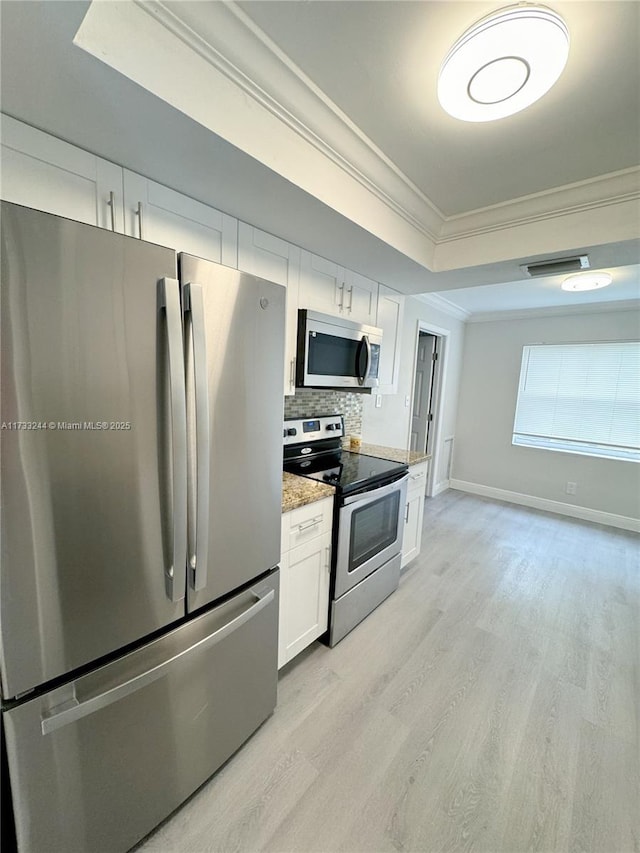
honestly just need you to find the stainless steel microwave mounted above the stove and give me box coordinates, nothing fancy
[296,309,382,391]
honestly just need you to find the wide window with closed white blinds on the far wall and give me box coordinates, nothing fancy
[513,341,640,462]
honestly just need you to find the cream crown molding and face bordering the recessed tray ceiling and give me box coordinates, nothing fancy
[74,0,640,271]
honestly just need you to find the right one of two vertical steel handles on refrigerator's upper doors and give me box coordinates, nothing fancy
[184,282,211,590]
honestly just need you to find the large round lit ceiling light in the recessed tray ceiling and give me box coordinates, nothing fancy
[438,4,569,121]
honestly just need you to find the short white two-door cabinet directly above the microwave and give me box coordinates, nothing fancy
[299,251,378,326]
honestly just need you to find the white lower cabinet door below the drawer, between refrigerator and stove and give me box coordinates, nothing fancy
[278,536,331,666]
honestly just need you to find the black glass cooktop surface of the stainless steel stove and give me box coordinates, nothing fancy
[284,450,407,494]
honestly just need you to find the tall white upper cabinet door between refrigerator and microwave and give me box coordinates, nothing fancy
[238,222,300,395]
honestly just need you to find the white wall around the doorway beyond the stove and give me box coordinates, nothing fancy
[362,297,465,487]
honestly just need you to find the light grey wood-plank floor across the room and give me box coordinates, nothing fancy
[138,491,640,853]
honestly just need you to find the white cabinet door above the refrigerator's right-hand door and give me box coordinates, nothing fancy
[124,169,238,269]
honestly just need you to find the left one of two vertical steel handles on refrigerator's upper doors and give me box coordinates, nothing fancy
[158,278,187,602]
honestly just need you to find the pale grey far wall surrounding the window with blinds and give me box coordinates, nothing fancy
[452,311,640,523]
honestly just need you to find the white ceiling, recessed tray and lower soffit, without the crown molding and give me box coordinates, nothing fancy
[0,0,640,312]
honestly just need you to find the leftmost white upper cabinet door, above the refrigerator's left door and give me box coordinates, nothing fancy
[2,116,123,233]
